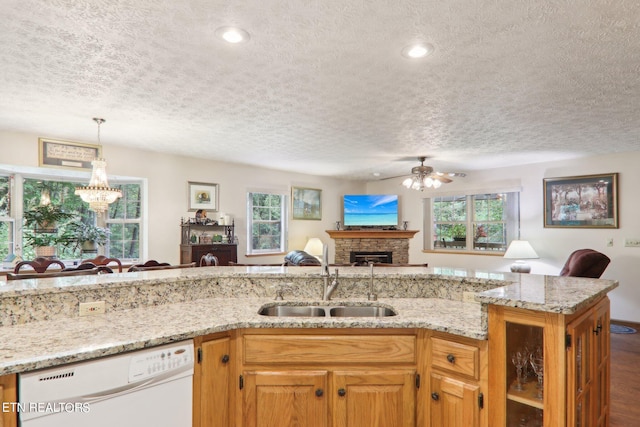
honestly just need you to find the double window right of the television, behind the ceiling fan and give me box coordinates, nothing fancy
[425,192,520,252]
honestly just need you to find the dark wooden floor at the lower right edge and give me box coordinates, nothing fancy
[610,321,640,427]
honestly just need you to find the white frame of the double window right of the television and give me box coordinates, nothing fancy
[423,189,520,256]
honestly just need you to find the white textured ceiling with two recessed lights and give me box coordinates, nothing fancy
[0,0,640,179]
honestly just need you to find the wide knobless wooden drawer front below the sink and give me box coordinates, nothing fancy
[244,335,416,364]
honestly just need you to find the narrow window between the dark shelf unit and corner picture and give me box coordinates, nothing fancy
[247,192,287,255]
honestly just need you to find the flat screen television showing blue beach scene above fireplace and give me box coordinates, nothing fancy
[343,194,398,227]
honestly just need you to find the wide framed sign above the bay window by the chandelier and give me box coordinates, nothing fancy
[38,138,102,170]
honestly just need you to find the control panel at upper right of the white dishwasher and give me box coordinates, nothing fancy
[129,341,194,383]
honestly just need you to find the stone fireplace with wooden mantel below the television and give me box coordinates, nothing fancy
[327,230,418,264]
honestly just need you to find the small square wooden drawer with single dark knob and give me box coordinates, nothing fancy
[431,338,479,379]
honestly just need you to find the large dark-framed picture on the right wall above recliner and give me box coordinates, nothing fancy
[543,173,618,228]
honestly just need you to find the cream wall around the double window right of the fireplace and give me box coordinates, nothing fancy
[367,152,640,322]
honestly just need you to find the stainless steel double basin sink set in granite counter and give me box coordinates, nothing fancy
[258,304,398,317]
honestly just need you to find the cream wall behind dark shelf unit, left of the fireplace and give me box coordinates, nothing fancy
[0,131,364,264]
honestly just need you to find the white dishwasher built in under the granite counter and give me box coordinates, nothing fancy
[18,340,194,427]
